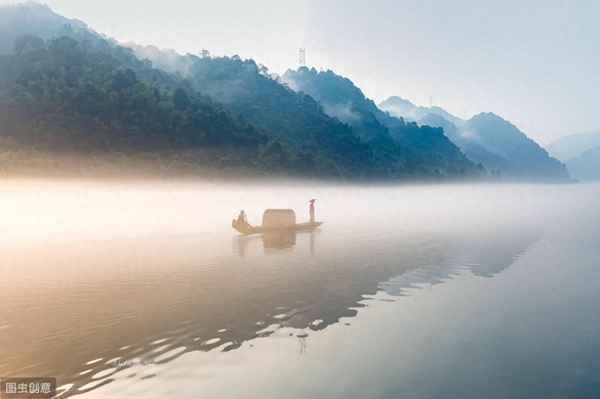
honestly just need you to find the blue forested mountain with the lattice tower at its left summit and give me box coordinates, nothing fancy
[282,67,478,174]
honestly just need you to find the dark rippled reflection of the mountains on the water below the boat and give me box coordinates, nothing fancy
[0,225,537,392]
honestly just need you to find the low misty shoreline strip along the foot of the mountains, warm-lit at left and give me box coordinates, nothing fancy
[0,148,576,184]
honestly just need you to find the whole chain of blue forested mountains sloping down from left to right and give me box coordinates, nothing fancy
[0,3,562,179]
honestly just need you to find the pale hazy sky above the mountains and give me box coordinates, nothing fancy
[5,0,600,143]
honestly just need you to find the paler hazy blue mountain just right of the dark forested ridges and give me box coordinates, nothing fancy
[380,97,569,181]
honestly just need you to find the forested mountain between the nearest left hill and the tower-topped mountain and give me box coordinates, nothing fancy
[127,46,392,178]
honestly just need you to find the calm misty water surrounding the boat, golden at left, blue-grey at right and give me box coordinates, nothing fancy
[0,180,600,398]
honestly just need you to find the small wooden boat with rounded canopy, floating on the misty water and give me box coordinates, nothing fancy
[231,209,323,235]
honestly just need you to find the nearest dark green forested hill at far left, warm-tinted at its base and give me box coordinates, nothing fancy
[0,36,265,150]
